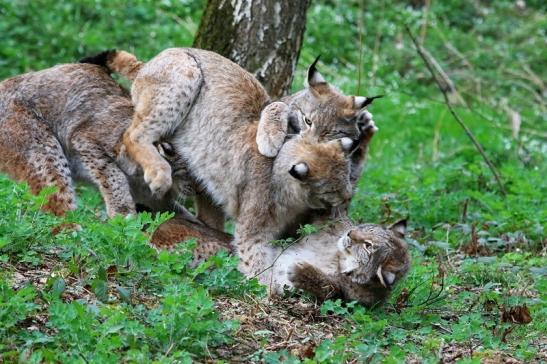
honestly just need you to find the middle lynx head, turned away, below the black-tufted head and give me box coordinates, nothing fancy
[273,130,353,209]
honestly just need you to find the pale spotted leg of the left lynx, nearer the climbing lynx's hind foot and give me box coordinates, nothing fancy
[72,135,136,217]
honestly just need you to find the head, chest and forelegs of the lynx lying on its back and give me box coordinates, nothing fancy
[284,220,410,306]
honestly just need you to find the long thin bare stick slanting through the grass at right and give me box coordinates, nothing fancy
[405,25,506,195]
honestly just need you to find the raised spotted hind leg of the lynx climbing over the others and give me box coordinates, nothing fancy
[123,50,203,196]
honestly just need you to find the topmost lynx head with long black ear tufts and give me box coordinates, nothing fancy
[282,57,381,141]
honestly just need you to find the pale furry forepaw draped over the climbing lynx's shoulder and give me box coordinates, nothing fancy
[256,101,289,158]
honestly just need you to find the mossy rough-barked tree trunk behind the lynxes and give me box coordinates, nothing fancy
[194,0,311,98]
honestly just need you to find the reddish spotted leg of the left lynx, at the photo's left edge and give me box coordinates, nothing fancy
[0,110,76,216]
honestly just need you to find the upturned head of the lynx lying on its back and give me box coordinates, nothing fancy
[338,220,410,295]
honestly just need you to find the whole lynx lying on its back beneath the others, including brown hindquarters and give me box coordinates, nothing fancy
[151,217,410,306]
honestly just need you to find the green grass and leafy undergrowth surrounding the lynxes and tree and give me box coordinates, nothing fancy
[0,0,547,363]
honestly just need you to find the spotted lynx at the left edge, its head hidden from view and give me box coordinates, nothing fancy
[0,64,196,218]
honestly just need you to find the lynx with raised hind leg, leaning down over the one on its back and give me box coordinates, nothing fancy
[81,48,357,274]
